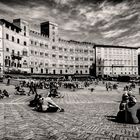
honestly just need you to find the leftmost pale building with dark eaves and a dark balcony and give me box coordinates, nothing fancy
[0,19,29,73]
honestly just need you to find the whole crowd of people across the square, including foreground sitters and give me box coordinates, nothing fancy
[0,76,140,123]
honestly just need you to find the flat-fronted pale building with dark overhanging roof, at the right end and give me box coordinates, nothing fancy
[95,45,138,77]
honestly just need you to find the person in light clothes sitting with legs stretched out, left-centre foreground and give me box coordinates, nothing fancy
[36,95,64,112]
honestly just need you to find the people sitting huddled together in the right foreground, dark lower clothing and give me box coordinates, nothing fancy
[117,88,140,124]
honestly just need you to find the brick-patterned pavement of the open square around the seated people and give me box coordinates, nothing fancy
[0,84,140,140]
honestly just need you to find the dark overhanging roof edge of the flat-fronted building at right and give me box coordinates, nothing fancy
[94,44,138,49]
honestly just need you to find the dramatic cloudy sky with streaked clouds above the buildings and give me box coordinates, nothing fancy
[0,0,140,46]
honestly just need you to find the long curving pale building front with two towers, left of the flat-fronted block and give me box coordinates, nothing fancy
[0,19,95,74]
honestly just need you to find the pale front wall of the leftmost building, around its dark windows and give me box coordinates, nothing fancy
[3,22,29,72]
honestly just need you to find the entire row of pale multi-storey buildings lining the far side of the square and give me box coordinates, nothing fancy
[0,19,138,77]
